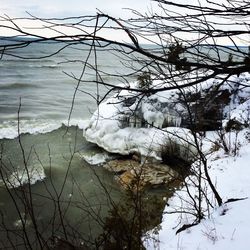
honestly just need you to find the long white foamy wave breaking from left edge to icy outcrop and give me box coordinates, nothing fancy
[0,119,87,139]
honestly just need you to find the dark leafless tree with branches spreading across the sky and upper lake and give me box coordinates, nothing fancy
[0,0,250,247]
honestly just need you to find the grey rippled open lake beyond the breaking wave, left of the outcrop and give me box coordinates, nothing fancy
[0,38,137,131]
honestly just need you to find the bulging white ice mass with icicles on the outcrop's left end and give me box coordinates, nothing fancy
[83,83,194,160]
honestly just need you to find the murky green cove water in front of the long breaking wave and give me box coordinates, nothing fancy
[0,127,122,244]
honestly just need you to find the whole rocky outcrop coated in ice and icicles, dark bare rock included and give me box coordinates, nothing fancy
[83,74,250,162]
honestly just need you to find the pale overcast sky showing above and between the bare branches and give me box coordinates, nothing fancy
[0,0,249,44]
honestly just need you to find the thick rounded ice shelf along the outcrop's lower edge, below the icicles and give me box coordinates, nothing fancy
[84,120,192,160]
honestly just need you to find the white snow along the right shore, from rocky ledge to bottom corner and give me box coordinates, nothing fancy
[143,74,250,250]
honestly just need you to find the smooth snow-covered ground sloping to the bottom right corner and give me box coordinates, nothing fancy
[147,130,250,250]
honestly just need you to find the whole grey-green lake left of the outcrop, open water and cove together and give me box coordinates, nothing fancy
[0,38,172,249]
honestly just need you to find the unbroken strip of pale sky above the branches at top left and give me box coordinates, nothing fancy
[0,0,150,18]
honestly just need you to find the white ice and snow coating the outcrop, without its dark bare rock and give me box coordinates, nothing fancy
[83,74,250,160]
